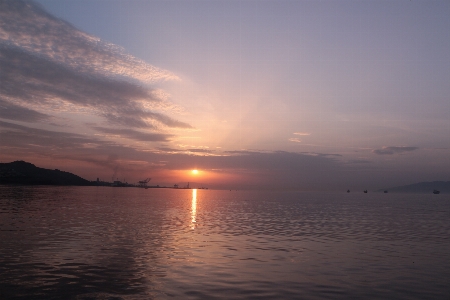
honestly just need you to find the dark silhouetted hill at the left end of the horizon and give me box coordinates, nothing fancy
[0,161,91,185]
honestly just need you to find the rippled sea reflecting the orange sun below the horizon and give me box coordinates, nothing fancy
[0,186,450,300]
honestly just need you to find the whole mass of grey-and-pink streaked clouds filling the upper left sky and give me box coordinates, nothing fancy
[0,1,192,129]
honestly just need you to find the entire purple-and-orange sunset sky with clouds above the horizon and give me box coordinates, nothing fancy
[0,0,450,190]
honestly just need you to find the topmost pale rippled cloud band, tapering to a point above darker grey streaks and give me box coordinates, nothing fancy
[0,0,178,82]
